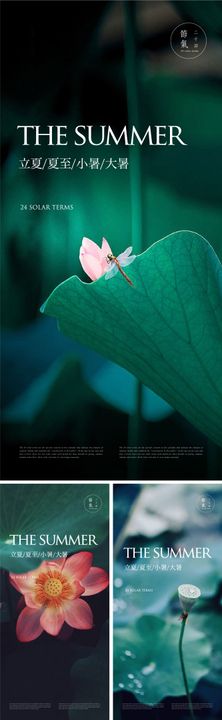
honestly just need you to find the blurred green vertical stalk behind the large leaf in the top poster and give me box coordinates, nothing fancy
[124,0,143,480]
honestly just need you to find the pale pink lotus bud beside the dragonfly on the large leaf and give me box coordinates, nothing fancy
[79,238,112,280]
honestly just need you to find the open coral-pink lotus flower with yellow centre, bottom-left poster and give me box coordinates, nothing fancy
[9,552,109,642]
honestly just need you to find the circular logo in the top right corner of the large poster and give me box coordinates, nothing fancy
[170,22,207,60]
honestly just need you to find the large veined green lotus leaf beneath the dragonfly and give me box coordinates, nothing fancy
[42,231,222,445]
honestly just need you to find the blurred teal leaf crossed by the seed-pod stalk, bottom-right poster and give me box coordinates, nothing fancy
[114,616,210,705]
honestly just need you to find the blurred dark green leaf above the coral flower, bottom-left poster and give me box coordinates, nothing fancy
[0,483,109,572]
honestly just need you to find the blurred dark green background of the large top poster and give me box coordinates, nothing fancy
[2,1,222,480]
